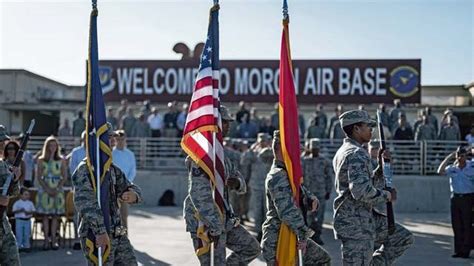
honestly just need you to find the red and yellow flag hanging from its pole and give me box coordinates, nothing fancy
[276,1,303,265]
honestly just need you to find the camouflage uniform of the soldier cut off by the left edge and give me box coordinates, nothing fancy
[0,160,20,266]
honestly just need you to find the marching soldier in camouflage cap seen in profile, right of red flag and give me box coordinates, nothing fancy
[333,110,413,265]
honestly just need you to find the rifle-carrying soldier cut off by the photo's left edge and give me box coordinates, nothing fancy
[0,134,21,266]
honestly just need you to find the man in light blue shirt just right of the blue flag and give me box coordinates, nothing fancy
[112,130,137,227]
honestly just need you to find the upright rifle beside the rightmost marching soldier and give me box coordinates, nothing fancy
[377,111,395,235]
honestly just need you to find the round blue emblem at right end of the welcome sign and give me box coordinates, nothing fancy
[390,66,420,97]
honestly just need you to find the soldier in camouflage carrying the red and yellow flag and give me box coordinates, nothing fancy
[261,130,331,265]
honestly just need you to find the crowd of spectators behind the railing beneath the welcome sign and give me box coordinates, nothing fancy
[58,99,474,147]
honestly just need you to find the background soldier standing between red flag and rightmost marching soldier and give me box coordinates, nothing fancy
[301,139,334,245]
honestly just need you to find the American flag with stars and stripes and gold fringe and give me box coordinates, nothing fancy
[181,4,225,249]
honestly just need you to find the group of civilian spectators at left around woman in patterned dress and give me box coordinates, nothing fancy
[0,122,137,251]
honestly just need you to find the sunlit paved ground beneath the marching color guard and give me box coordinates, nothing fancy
[21,207,474,266]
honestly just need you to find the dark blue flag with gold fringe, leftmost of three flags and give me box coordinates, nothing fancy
[85,6,112,264]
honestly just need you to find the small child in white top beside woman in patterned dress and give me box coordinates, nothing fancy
[13,188,35,251]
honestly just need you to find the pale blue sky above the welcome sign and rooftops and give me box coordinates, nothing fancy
[0,0,474,85]
